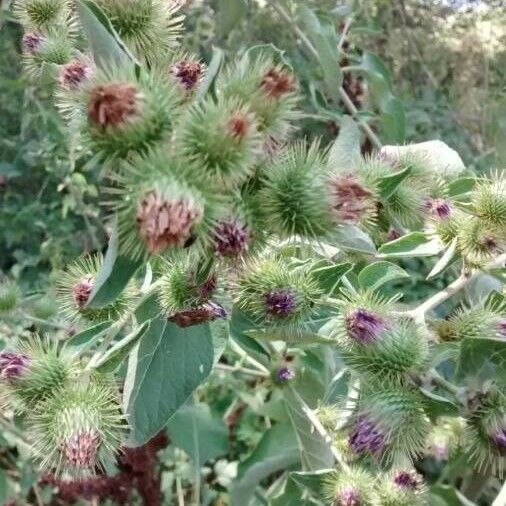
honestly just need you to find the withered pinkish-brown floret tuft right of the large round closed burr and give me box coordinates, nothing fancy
[329,174,374,223]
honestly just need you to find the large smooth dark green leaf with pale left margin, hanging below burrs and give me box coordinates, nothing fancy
[124,318,214,444]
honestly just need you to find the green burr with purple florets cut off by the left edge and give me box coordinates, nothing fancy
[0,338,75,412]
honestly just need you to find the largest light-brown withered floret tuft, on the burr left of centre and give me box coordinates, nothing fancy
[137,191,203,254]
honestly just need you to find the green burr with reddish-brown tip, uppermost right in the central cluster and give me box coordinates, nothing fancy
[217,57,298,140]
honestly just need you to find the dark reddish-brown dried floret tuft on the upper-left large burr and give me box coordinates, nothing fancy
[88,83,139,128]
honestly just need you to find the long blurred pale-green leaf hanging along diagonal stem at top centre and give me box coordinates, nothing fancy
[298,5,343,104]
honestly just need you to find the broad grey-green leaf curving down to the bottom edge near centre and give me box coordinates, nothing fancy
[230,423,300,506]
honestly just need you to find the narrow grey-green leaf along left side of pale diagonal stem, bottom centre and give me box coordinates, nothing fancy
[283,387,334,471]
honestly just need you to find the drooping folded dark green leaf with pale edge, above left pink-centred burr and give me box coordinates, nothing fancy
[86,224,142,309]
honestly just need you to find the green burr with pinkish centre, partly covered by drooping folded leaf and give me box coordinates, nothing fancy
[56,255,136,322]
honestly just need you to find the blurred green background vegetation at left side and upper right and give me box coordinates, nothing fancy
[0,0,506,289]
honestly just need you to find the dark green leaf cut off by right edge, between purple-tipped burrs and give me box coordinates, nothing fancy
[456,338,506,382]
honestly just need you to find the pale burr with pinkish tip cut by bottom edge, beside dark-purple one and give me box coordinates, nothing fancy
[323,467,377,506]
